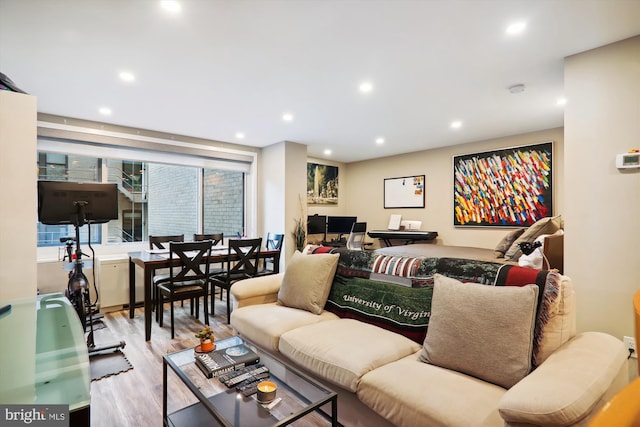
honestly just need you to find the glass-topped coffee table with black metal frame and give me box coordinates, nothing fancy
[162,336,339,427]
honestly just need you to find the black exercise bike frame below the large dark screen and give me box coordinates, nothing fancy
[60,201,126,357]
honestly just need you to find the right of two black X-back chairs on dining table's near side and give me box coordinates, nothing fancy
[210,237,262,323]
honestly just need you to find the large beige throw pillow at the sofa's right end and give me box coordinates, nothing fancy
[420,274,538,388]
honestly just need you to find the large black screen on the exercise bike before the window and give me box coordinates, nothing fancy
[38,181,118,226]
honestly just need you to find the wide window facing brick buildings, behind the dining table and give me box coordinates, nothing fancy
[38,151,245,246]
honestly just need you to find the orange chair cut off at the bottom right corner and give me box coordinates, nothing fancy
[589,291,640,427]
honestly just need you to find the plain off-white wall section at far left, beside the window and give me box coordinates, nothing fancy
[0,90,38,301]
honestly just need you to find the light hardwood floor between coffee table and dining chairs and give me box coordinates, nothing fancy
[91,298,238,427]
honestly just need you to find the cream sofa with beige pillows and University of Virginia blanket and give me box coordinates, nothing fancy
[231,251,628,427]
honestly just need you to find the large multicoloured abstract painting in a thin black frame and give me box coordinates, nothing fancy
[453,142,553,227]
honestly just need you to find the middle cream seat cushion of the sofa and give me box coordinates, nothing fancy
[279,319,420,392]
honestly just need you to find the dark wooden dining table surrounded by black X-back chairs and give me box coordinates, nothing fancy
[127,249,280,341]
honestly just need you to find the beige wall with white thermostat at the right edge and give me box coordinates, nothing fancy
[565,36,640,338]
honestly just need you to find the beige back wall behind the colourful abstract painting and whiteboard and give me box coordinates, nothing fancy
[340,128,564,248]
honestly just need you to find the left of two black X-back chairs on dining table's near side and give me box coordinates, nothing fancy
[157,240,212,339]
